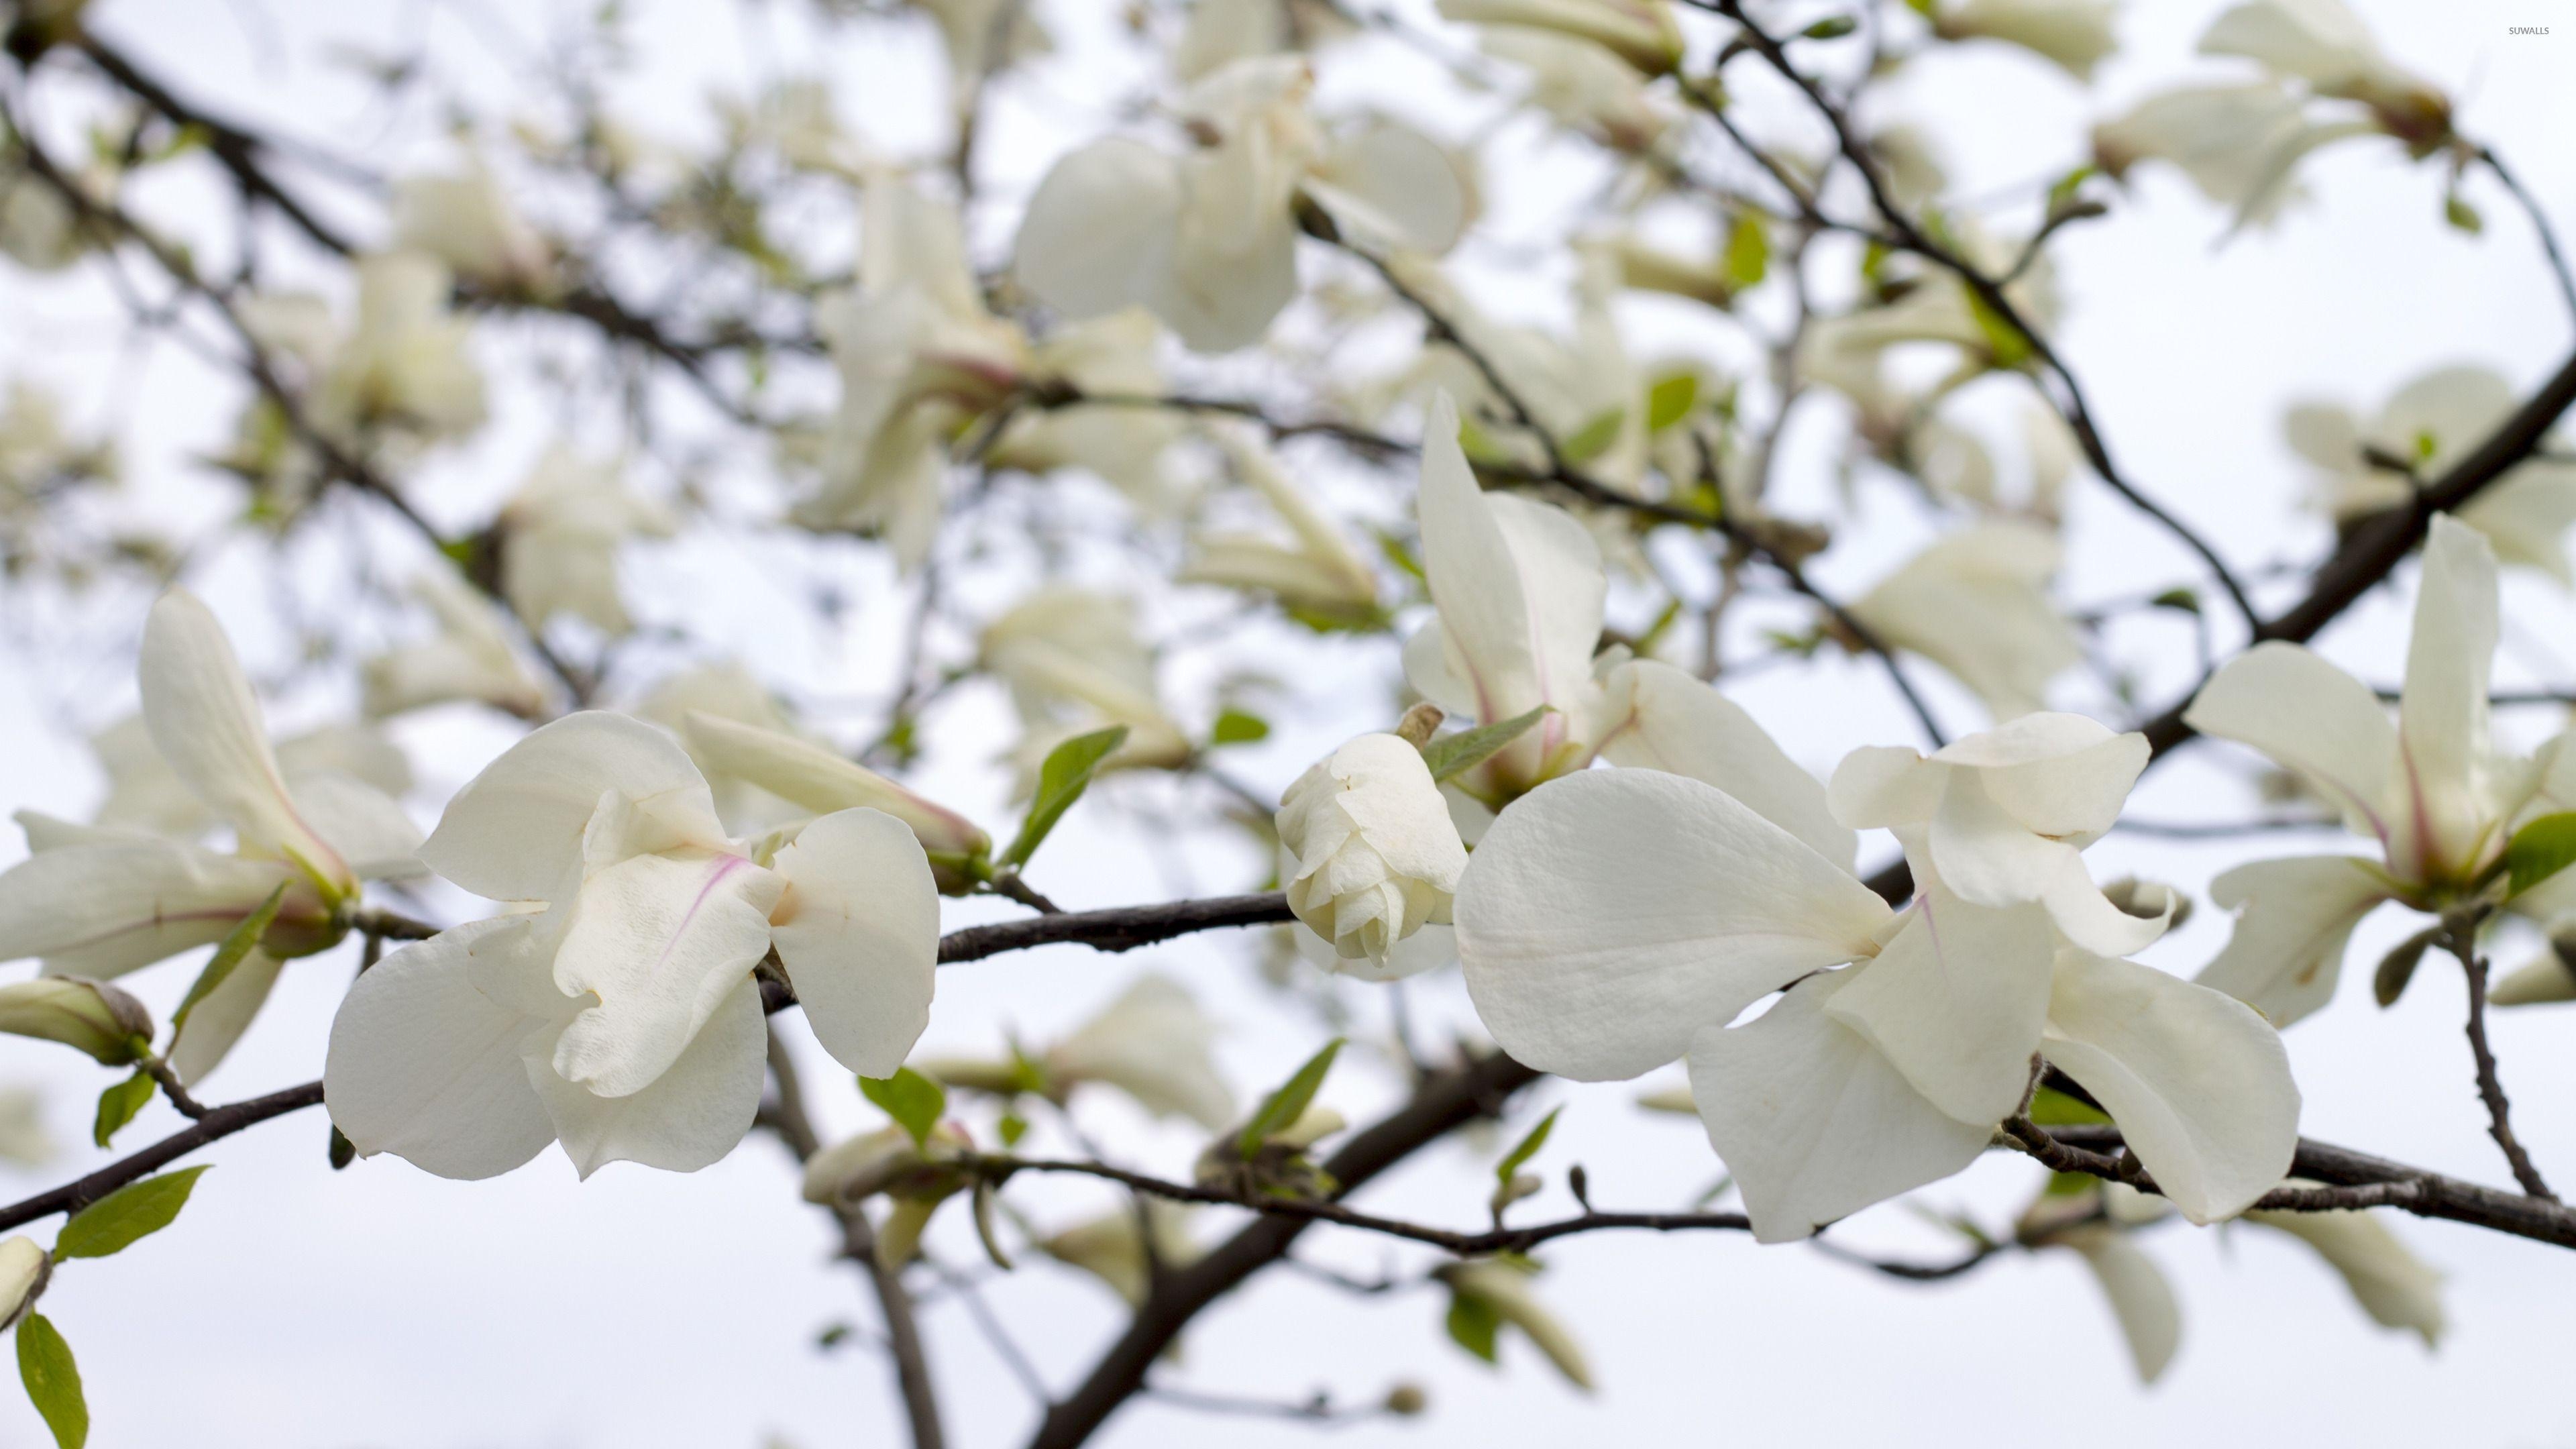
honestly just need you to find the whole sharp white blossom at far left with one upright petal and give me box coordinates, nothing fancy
[0,590,420,1080]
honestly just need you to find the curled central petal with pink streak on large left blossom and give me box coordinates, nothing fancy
[551,846,777,1095]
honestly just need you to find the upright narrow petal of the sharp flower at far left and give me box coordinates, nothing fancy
[137,588,350,890]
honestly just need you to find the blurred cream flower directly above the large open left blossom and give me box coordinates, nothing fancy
[494,446,678,634]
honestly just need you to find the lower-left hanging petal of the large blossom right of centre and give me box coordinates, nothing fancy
[1690,972,1994,1243]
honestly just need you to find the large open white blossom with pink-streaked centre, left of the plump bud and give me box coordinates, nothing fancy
[322,712,941,1178]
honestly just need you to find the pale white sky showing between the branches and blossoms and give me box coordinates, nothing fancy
[0,0,2576,1449]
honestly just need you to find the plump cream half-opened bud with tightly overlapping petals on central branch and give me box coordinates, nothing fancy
[1278,735,1466,969]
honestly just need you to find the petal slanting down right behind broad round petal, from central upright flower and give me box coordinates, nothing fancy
[1602,660,1858,869]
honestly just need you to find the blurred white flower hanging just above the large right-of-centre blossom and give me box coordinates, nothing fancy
[1849,519,2084,719]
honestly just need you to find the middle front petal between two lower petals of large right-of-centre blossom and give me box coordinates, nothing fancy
[1824,890,2055,1127]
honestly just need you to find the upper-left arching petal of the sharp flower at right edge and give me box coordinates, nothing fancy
[2182,639,2398,843]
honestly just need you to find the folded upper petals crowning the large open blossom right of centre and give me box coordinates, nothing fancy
[1829,714,2171,957]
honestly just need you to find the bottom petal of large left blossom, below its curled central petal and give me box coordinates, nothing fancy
[523,977,767,1178]
